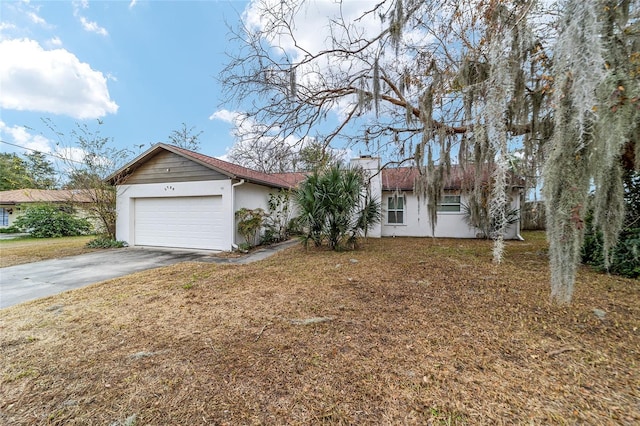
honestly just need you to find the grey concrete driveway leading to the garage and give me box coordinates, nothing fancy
[0,247,215,309]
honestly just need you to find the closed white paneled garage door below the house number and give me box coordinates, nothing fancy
[133,196,229,250]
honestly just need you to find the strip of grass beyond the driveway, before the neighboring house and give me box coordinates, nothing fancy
[0,235,95,268]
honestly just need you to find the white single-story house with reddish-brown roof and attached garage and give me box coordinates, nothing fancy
[110,143,520,250]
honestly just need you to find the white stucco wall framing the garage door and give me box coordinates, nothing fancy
[116,180,235,249]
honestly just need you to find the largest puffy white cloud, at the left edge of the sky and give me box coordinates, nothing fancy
[0,39,118,119]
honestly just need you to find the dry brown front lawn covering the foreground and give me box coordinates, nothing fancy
[0,234,640,425]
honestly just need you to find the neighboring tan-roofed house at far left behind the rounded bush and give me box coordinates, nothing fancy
[0,189,90,228]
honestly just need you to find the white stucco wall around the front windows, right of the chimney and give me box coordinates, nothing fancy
[381,191,520,239]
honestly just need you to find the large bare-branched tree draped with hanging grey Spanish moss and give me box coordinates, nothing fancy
[221,0,640,303]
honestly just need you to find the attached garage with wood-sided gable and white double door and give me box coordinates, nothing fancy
[108,144,294,250]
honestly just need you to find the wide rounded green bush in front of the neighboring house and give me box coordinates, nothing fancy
[13,204,92,238]
